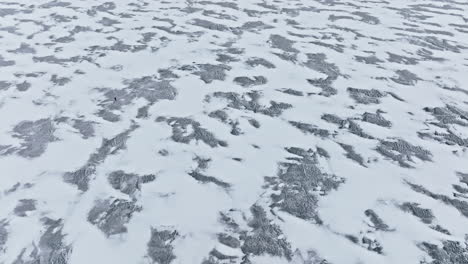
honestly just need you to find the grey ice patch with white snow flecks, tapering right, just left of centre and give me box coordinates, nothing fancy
[156,117,227,148]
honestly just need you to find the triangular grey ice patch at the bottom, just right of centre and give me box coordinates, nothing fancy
[241,205,292,260]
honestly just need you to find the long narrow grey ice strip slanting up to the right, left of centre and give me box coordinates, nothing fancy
[63,124,138,191]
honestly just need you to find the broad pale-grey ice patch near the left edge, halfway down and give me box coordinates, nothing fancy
[13,118,58,158]
